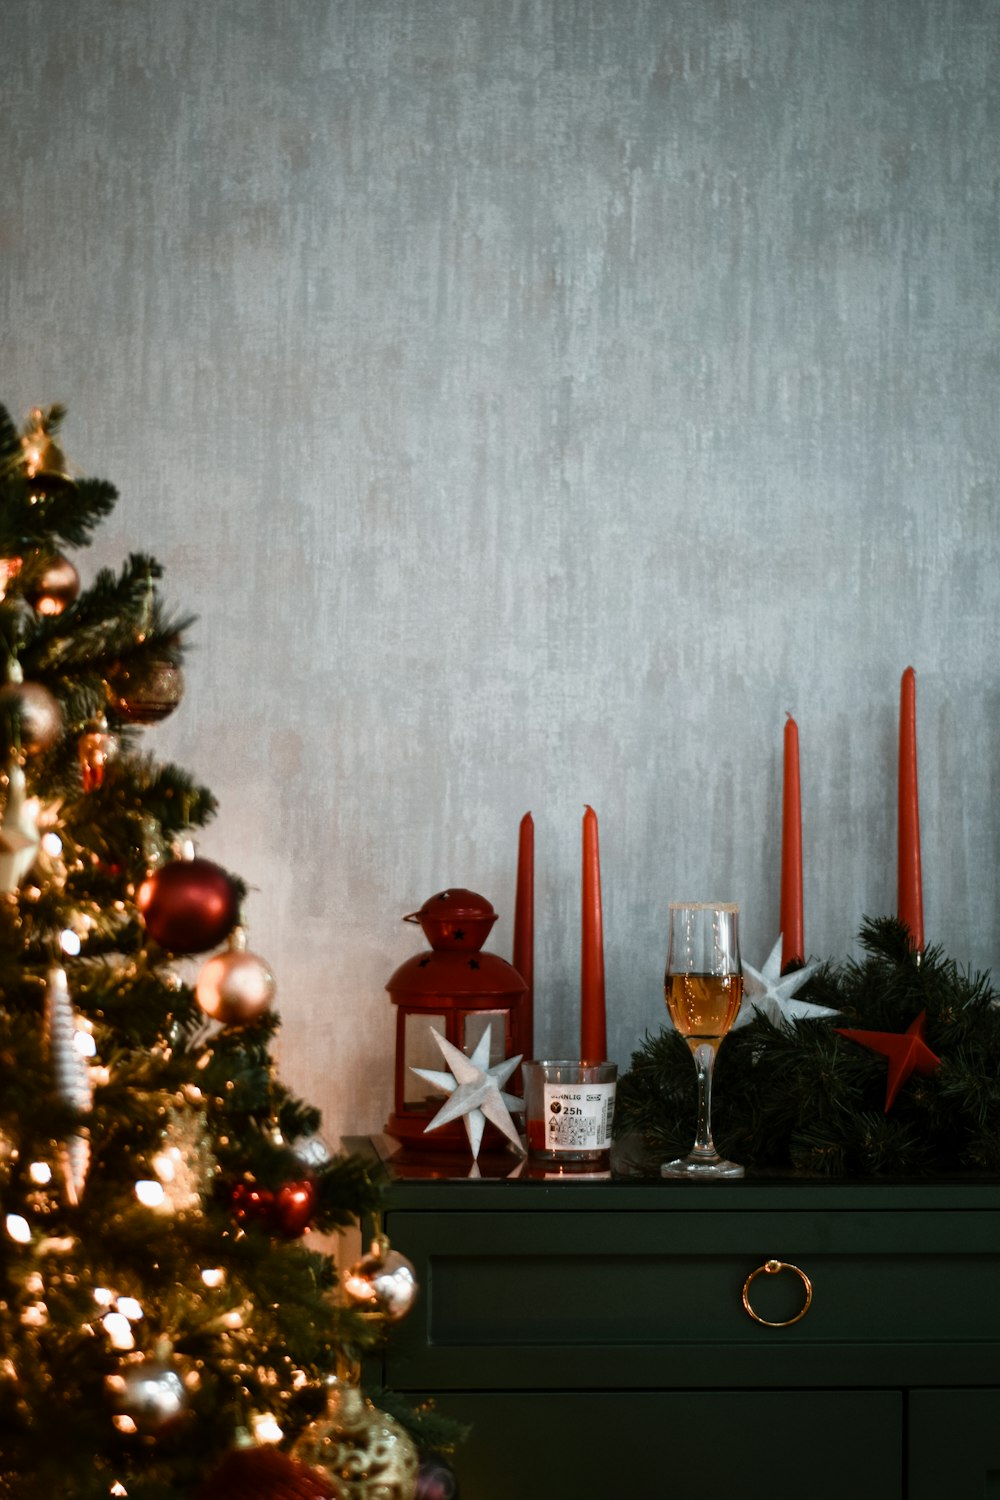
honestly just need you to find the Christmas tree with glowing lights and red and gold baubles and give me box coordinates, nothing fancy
[0,408,412,1500]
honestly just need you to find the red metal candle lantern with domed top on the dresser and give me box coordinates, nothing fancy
[385,887,531,1151]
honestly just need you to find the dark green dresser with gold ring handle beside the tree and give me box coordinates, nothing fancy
[349,1142,1000,1500]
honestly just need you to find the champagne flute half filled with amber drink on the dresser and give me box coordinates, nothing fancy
[660,902,744,1181]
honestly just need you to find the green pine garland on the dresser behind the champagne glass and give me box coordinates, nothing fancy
[615,918,1000,1176]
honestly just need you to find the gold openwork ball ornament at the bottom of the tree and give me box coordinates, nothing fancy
[292,1379,420,1500]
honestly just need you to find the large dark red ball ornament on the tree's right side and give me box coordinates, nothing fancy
[135,860,240,953]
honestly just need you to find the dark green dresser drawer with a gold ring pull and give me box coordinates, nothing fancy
[385,1209,1000,1391]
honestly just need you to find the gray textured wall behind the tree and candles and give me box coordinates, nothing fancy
[0,0,1000,1134]
